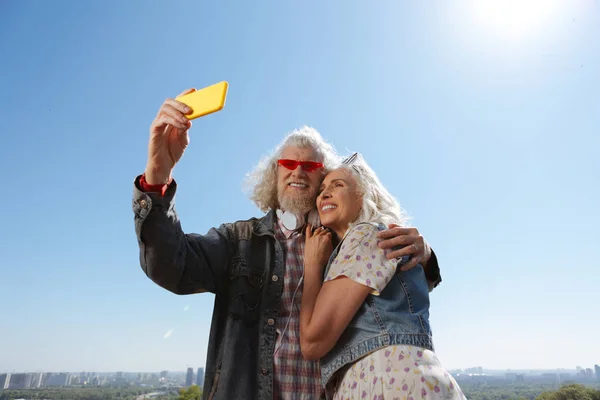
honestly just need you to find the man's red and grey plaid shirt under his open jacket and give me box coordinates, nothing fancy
[273,219,324,400]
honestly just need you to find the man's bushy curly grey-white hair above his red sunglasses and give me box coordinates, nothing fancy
[244,126,341,212]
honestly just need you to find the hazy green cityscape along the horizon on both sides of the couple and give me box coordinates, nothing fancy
[0,364,600,399]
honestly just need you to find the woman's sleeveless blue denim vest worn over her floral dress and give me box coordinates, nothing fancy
[320,224,433,391]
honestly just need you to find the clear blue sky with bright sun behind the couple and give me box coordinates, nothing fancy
[0,0,600,371]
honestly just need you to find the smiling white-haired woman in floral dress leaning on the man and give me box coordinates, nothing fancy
[300,154,465,400]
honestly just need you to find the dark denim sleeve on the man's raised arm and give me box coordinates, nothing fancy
[133,176,232,294]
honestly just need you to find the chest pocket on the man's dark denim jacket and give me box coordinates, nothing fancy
[228,258,264,325]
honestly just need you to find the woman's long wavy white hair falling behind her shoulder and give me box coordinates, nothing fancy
[340,153,410,229]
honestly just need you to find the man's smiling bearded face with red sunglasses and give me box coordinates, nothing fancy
[277,146,323,215]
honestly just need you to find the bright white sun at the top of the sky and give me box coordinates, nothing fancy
[471,0,568,39]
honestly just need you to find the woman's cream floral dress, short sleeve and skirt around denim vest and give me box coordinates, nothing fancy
[325,224,466,400]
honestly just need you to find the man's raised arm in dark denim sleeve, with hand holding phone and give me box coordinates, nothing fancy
[133,89,231,294]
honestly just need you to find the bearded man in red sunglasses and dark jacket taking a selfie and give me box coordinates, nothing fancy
[133,89,441,400]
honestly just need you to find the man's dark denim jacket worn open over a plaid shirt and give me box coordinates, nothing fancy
[132,176,441,400]
